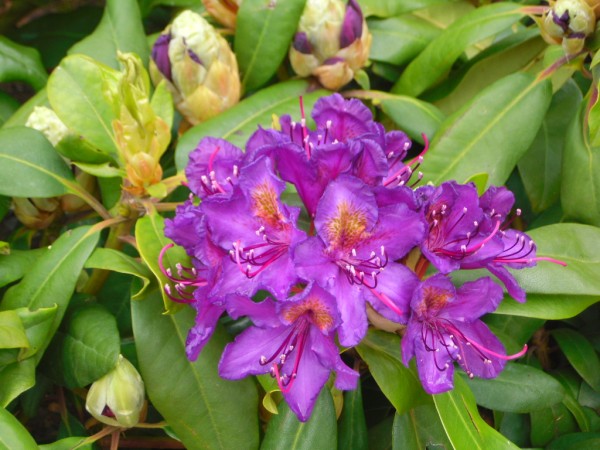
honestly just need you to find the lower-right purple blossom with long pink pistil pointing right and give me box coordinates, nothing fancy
[402,274,527,394]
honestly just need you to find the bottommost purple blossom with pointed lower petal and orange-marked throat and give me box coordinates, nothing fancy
[219,284,358,422]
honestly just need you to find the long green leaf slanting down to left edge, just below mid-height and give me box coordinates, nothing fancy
[0,227,98,362]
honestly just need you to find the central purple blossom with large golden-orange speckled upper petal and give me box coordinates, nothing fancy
[294,175,424,345]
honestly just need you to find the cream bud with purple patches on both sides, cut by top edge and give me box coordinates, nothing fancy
[290,0,371,90]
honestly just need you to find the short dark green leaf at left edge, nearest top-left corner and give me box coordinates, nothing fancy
[0,36,48,91]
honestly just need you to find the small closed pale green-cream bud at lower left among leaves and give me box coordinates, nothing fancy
[85,355,144,428]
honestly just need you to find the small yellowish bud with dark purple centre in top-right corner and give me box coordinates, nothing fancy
[538,0,596,55]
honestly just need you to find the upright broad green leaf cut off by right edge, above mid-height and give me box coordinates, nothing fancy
[560,102,600,226]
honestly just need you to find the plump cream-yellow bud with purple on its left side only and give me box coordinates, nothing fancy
[150,11,240,125]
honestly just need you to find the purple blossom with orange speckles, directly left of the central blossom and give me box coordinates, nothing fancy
[200,157,306,299]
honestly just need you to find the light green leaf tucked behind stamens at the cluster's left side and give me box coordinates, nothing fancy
[135,214,189,313]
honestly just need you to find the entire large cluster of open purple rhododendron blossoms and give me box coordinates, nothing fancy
[161,94,552,421]
